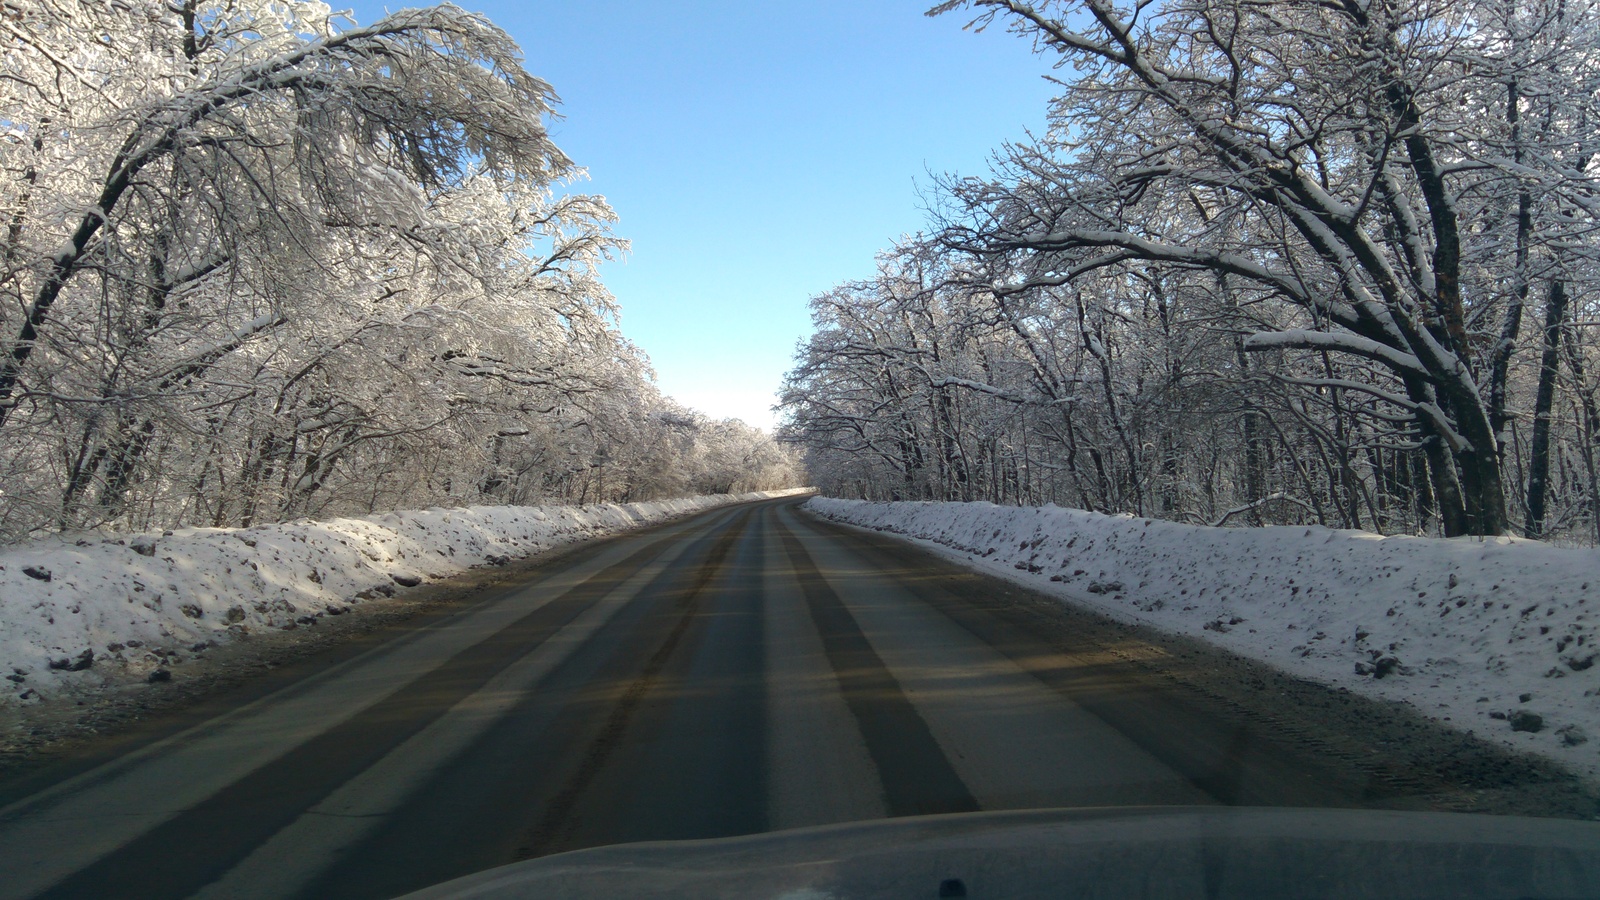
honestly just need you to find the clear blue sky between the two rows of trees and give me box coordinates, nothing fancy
[336,0,1053,428]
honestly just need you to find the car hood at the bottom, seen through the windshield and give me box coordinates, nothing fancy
[396,807,1600,900]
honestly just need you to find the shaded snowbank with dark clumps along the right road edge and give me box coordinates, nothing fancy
[806,498,1600,777]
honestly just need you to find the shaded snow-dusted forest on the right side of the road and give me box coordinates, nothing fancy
[782,0,1600,534]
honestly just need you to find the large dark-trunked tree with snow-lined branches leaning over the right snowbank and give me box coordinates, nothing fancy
[933,0,1595,535]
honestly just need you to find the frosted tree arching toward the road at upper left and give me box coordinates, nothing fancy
[0,0,570,426]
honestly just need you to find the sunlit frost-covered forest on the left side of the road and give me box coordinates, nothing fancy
[0,0,798,543]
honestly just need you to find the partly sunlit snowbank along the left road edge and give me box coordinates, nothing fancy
[0,490,812,705]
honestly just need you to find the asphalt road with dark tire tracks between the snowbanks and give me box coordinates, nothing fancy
[0,500,1440,900]
